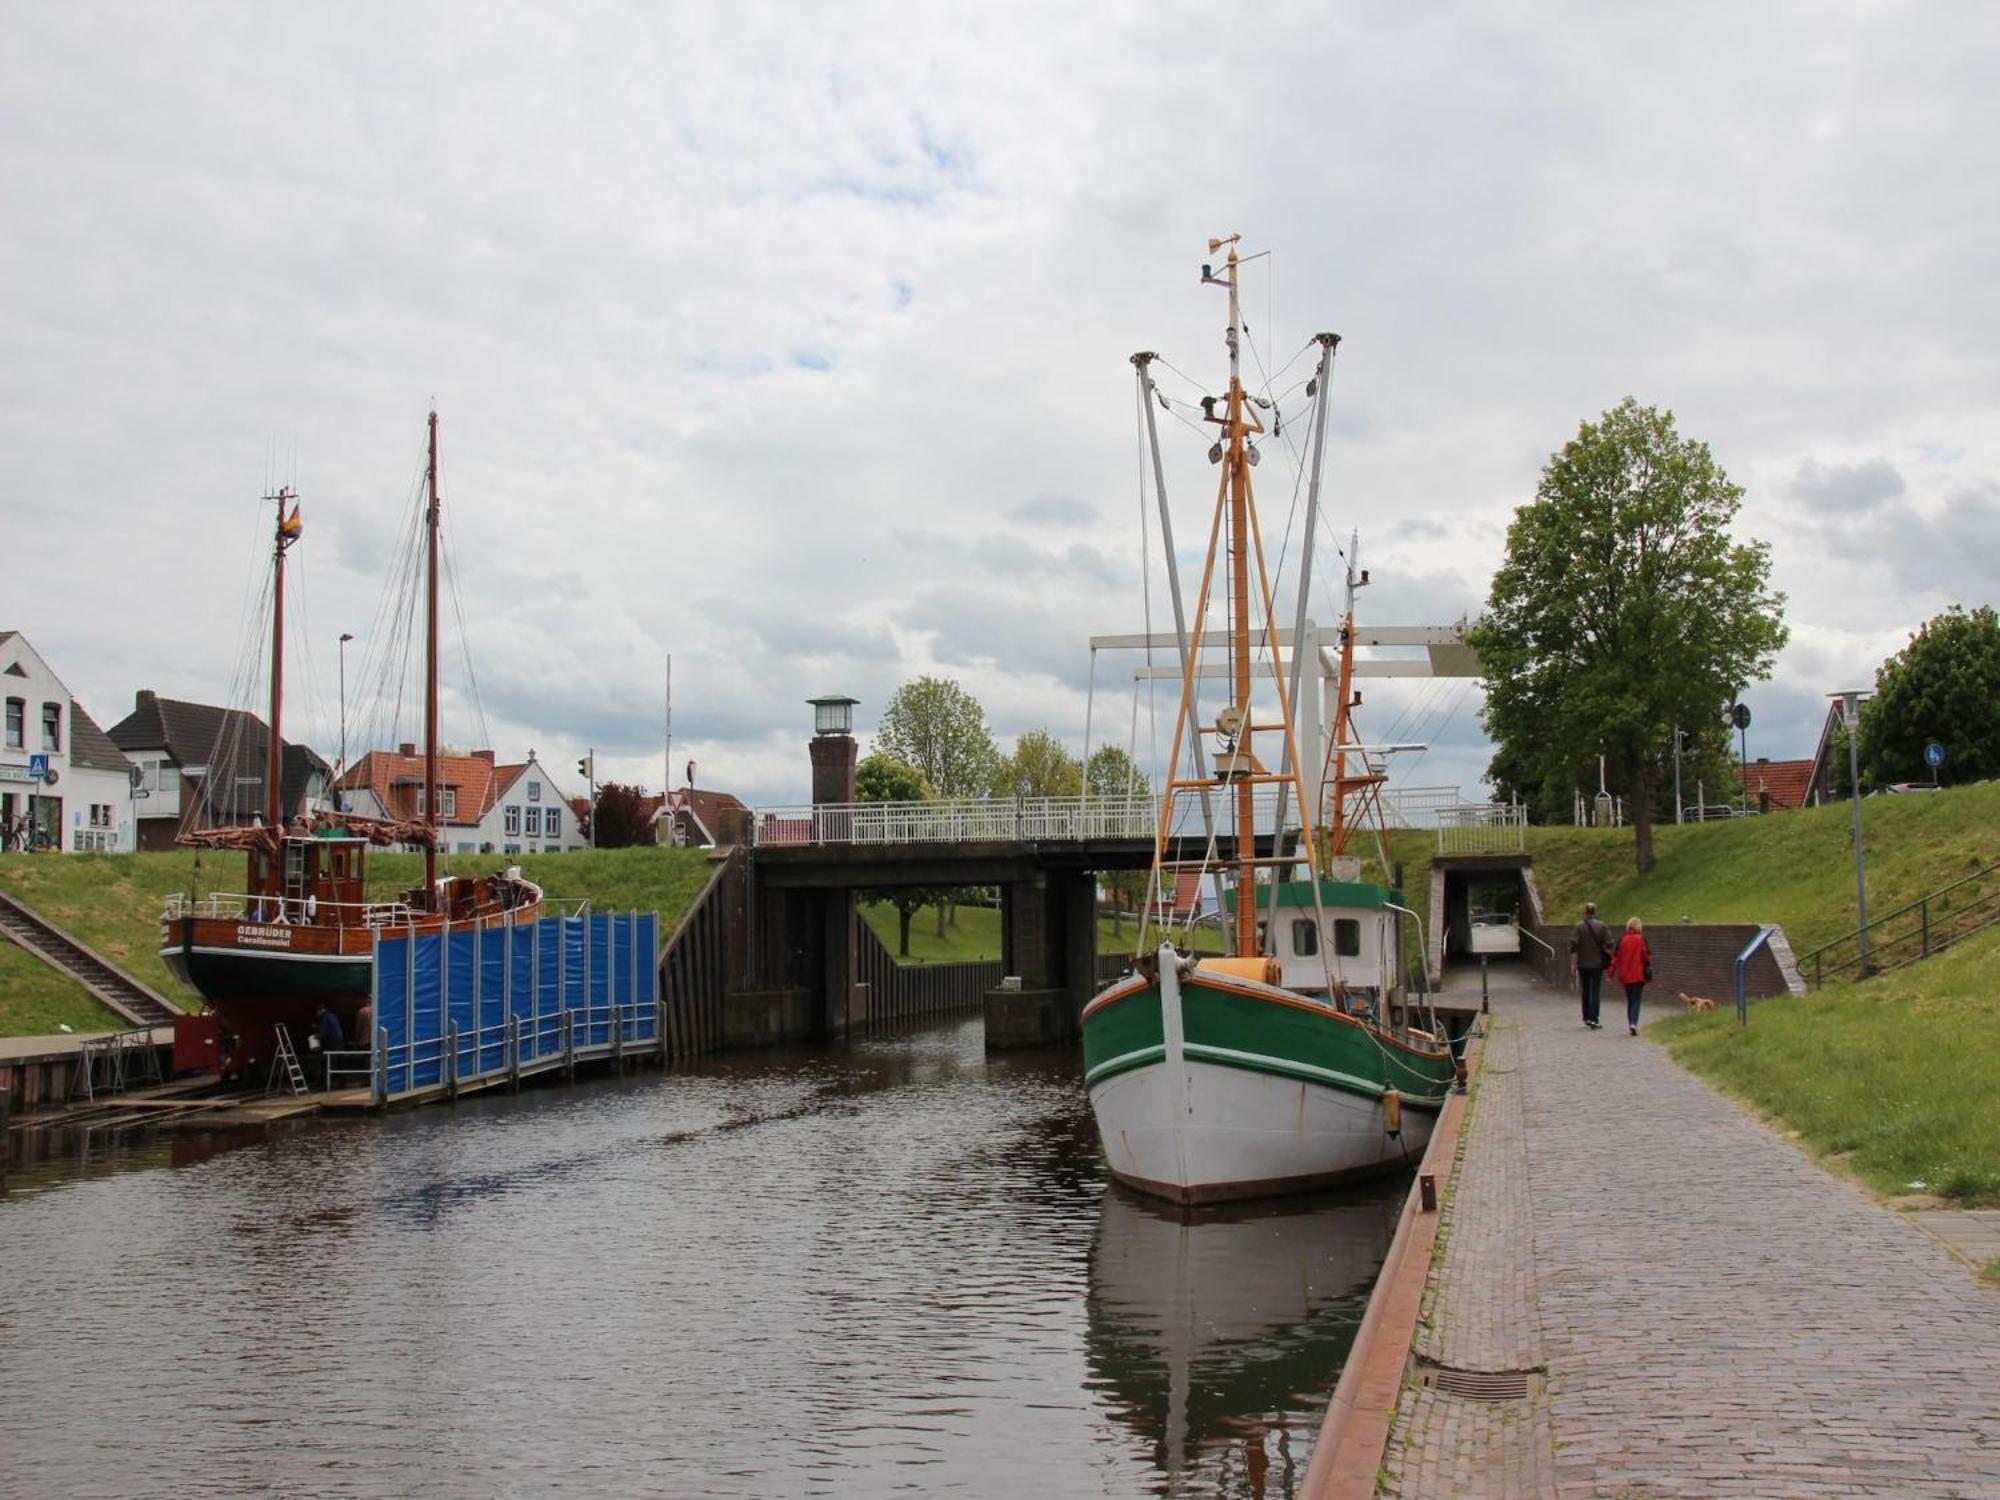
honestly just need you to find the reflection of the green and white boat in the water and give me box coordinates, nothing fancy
[1088,1182,1404,1494]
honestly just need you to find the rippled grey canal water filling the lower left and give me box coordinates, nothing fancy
[0,1020,1404,1496]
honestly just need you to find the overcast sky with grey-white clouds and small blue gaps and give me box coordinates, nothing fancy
[0,0,2000,824]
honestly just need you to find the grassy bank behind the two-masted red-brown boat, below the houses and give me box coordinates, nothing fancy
[0,848,712,1036]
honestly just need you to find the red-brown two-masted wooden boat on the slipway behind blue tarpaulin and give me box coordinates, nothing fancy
[160,412,542,1076]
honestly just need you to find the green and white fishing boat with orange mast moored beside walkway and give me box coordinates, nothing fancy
[1082,236,1456,1204]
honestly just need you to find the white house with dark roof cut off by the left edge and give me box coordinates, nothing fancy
[0,630,134,852]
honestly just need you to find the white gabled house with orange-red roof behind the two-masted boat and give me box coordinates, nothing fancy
[340,744,584,854]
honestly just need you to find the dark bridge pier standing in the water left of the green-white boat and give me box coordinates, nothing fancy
[986,870,1098,1050]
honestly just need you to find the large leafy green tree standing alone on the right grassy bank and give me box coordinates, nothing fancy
[1470,396,1790,872]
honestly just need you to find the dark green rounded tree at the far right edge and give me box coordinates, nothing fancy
[1840,604,2000,786]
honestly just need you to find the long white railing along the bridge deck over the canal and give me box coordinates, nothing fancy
[752,786,1298,848]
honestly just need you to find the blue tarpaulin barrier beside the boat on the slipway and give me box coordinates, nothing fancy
[372,912,660,1098]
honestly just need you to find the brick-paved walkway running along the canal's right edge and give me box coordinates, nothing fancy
[1384,986,2000,1498]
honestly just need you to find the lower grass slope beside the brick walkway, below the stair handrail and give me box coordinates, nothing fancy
[1652,928,2000,1206]
